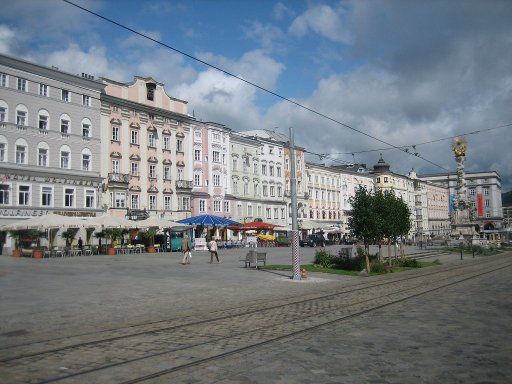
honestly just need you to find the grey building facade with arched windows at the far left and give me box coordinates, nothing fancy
[0,55,103,245]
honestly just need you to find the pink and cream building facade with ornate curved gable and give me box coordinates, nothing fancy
[101,76,195,220]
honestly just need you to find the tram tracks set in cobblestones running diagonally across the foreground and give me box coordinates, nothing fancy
[0,258,512,383]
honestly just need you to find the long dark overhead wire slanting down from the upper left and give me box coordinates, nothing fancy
[62,0,450,172]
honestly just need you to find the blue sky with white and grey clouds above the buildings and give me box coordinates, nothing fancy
[0,0,512,190]
